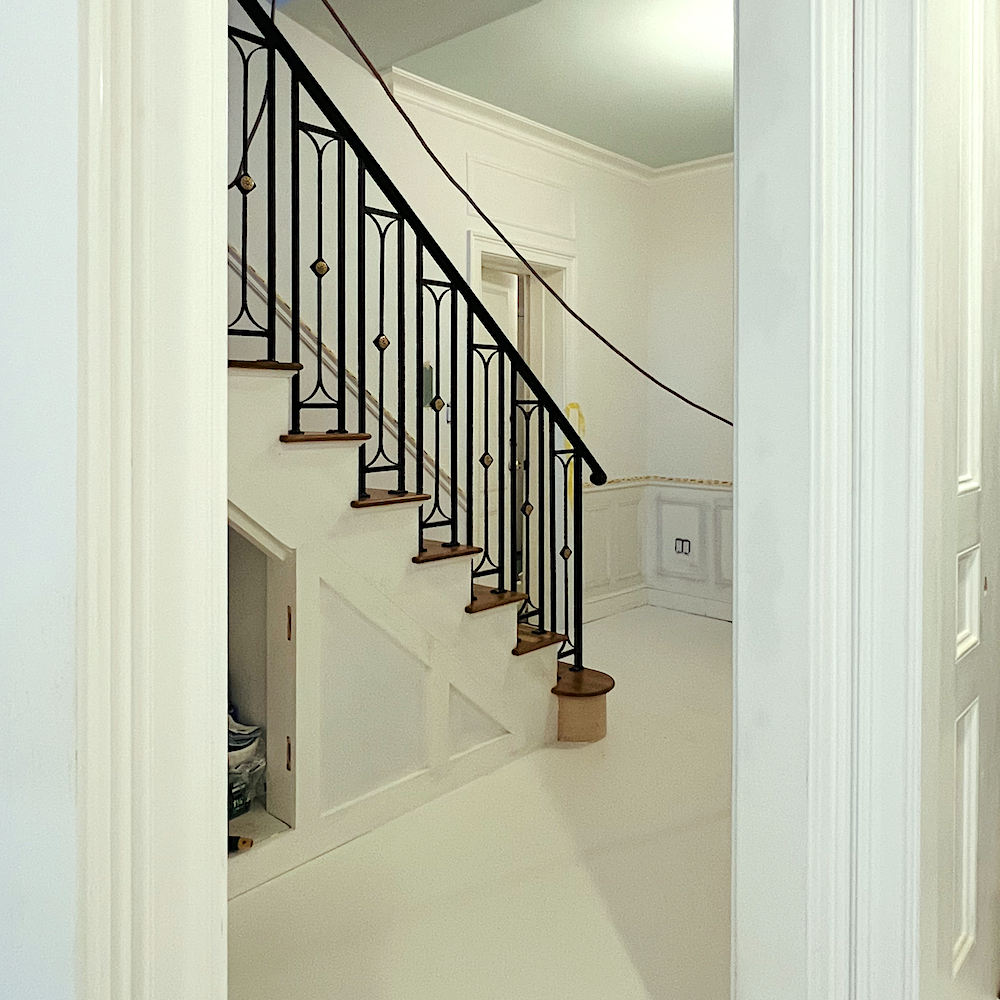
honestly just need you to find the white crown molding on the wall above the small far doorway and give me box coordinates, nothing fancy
[385,66,658,182]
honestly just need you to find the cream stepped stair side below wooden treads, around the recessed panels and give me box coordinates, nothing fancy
[229,373,556,896]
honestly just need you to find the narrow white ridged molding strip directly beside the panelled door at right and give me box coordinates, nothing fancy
[853,0,920,1000]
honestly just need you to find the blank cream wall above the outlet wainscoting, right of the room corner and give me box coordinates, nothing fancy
[646,156,734,480]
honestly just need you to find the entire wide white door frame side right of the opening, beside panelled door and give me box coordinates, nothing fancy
[732,0,920,1000]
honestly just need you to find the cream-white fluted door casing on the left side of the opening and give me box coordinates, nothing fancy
[77,0,227,1000]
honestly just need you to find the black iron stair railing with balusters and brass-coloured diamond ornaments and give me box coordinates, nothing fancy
[228,0,607,670]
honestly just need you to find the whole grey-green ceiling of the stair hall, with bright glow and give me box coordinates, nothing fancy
[283,0,733,167]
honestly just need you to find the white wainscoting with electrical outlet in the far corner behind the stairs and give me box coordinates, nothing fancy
[584,477,733,621]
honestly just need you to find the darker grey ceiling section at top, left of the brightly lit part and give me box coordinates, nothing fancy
[278,0,538,71]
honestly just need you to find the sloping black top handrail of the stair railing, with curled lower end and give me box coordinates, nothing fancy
[238,0,608,486]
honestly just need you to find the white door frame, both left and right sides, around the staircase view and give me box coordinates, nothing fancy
[78,0,935,1000]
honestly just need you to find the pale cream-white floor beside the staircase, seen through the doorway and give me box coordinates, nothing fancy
[229,607,732,1000]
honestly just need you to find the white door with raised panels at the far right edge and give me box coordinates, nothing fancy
[921,0,1000,1000]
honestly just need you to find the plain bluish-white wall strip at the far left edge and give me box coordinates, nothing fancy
[0,0,78,1000]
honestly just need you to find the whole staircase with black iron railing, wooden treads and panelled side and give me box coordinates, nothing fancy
[228,0,613,891]
